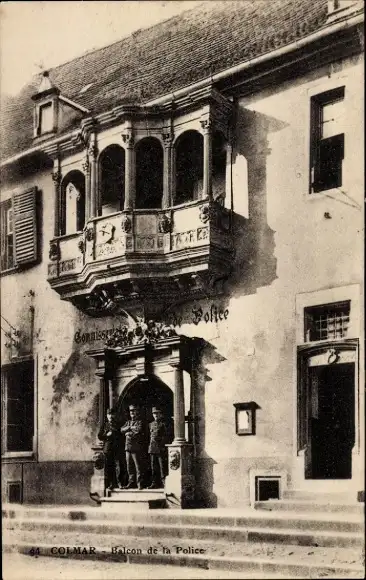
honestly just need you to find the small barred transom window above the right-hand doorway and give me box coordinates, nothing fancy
[304,301,351,342]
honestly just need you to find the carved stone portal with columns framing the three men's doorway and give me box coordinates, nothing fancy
[88,330,195,508]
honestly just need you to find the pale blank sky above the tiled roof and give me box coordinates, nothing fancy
[0,0,201,94]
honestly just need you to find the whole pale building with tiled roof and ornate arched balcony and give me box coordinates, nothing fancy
[1,0,364,507]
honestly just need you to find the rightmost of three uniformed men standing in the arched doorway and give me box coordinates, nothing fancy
[148,407,168,489]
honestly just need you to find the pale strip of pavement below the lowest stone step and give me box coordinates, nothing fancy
[2,553,286,580]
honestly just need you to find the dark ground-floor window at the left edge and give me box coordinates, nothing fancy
[1,360,34,453]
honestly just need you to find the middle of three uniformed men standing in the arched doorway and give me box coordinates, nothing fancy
[121,405,144,489]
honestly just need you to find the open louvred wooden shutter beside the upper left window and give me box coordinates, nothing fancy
[13,187,37,266]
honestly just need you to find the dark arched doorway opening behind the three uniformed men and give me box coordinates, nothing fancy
[116,375,174,486]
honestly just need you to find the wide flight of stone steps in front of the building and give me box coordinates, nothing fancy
[3,505,364,578]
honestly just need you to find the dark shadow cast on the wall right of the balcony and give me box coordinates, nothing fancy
[228,107,285,296]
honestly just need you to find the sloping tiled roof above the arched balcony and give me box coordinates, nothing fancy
[2,0,338,158]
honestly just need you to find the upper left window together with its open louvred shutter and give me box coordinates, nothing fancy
[0,187,38,272]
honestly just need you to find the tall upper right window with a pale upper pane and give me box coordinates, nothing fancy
[311,87,345,193]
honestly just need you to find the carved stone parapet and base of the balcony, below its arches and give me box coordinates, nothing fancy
[48,200,233,316]
